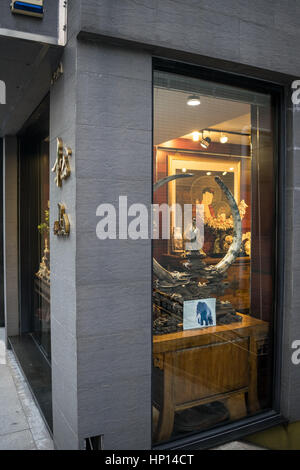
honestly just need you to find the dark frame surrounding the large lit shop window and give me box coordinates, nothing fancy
[151,57,288,450]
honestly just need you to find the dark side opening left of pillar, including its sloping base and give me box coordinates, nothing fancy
[9,97,52,429]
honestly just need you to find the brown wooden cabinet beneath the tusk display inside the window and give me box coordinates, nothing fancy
[153,315,269,442]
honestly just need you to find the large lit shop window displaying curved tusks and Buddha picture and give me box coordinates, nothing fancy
[153,71,276,443]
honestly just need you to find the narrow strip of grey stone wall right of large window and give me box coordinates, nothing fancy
[281,94,300,421]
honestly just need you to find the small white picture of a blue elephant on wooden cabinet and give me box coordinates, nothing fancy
[183,298,217,330]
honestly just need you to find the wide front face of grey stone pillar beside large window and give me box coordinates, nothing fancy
[76,42,152,449]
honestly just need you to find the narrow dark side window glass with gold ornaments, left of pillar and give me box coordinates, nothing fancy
[19,97,51,362]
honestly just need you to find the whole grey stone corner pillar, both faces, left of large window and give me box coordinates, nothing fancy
[50,36,152,449]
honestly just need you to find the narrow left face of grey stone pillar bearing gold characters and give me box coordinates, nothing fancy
[50,11,79,449]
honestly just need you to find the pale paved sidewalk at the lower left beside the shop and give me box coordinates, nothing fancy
[0,328,53,450]
